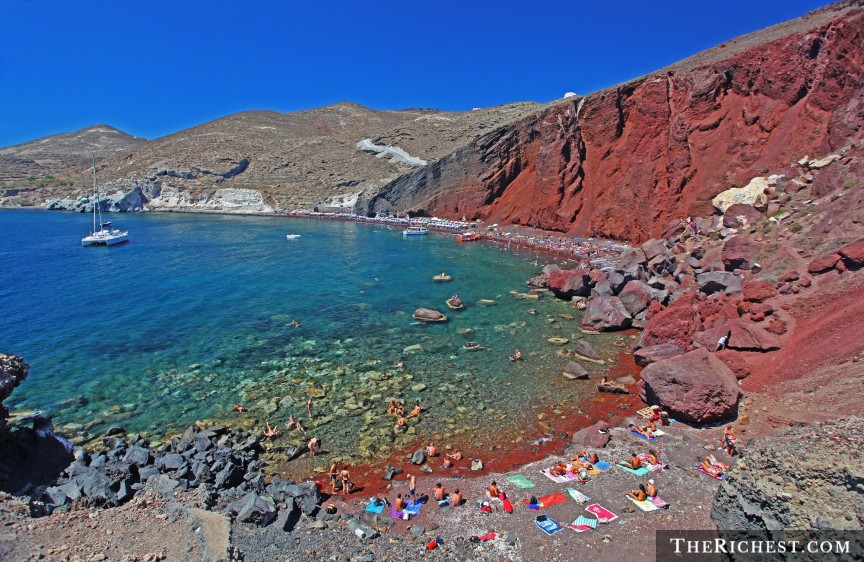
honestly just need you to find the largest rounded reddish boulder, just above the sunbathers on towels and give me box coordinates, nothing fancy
[641,349,741,424]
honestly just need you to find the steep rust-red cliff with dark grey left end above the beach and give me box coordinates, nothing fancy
[368,2,864,242]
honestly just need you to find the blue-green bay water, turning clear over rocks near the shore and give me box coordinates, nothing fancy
[0,210,620,457]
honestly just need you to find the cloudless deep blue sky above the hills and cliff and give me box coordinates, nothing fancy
[0,0,827,147]
